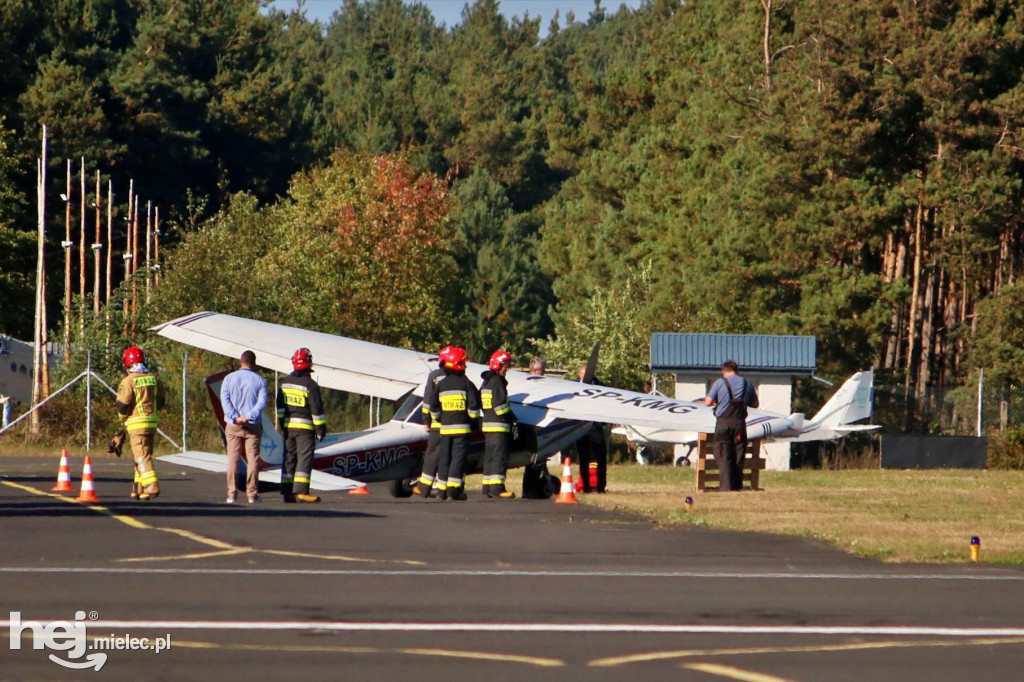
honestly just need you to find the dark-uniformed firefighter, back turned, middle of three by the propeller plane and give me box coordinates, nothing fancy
[430,347,480,501]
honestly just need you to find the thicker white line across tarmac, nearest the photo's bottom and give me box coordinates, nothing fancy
[6,621,1024,637]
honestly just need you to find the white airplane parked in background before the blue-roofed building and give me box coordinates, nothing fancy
[612,370,882,466]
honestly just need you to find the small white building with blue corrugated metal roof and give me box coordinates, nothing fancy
[650,333,817,471]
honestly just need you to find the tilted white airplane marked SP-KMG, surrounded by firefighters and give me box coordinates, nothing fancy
[151,312,872,497]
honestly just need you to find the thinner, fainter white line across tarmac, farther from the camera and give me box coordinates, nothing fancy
[0,566,1024,582]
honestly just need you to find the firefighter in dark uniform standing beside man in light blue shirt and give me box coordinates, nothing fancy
[278,348,327,503]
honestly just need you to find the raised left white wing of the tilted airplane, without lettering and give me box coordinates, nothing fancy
[150,312,437,400]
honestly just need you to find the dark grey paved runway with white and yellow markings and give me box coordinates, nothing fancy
[0,458,1024,682]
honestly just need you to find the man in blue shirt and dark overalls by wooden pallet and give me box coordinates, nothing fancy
[705,360,759,491]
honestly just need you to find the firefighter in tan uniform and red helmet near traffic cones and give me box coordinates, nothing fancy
[108,346,160,501]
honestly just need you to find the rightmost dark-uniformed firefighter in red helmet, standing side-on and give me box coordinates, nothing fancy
[480,350,516,500]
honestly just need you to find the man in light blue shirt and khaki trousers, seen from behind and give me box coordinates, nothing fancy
[220,350,266,505]
